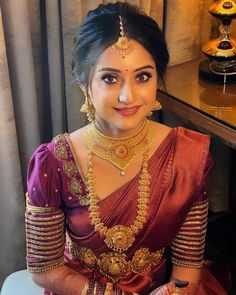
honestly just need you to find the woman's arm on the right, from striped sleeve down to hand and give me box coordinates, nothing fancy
[154,158,212,295]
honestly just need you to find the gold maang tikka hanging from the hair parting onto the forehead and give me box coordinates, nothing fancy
[111,15,133,58]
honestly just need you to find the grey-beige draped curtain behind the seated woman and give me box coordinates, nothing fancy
[0,0,221,285]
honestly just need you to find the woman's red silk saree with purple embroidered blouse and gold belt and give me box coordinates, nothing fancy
[26,127,229,295]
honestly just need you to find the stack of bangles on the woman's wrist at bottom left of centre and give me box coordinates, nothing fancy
[81,280,137,295]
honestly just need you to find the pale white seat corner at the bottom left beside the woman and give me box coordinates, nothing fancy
[1,269,44,295]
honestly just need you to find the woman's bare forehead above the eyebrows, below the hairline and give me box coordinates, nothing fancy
[95,40,155,70]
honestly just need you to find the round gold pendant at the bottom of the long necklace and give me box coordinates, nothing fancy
[105,225,135,252]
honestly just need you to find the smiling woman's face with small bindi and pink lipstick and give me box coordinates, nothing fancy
[89,40,157,137]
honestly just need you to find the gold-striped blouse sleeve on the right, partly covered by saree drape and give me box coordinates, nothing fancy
[171,156,212,268]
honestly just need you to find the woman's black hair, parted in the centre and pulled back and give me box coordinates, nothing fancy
[72,2,169,86]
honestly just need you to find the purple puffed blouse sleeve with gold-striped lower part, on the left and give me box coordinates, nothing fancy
[25,144,65,272]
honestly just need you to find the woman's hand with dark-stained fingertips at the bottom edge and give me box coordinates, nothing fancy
[149,280,189,295]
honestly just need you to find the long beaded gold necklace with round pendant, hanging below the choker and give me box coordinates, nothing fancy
[87,151,151,253]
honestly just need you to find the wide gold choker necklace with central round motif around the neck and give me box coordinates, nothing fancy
[84,120,153,176]
